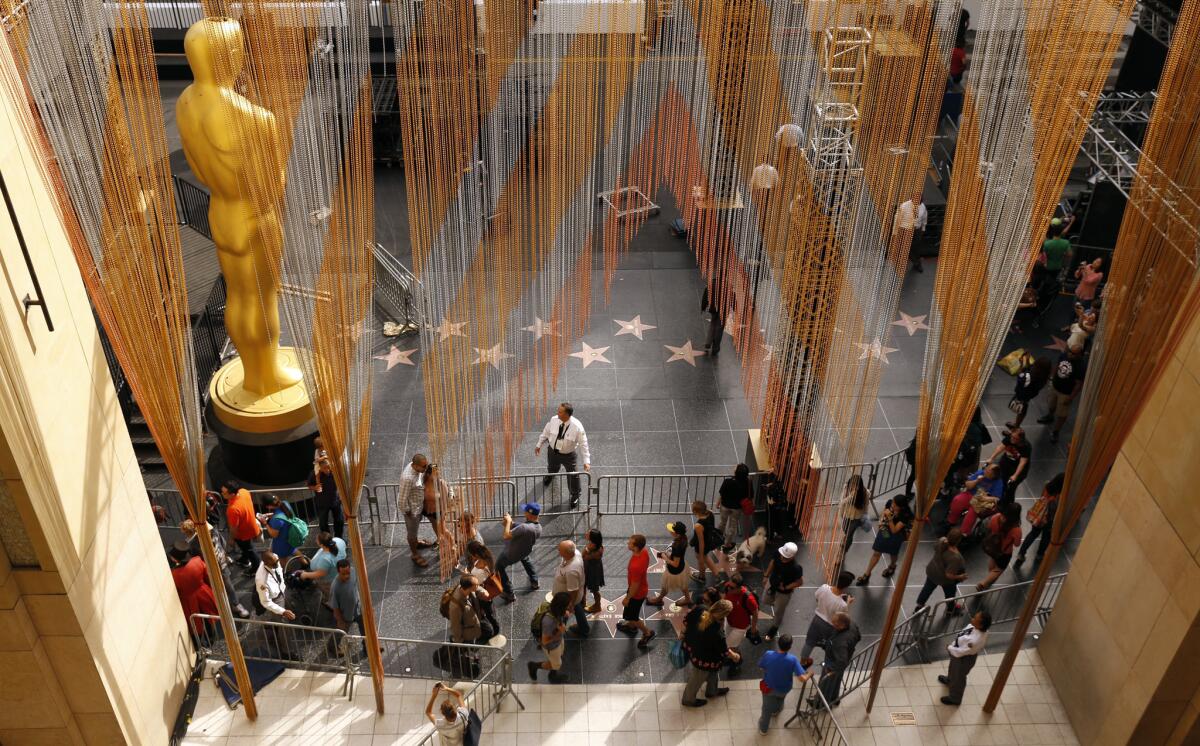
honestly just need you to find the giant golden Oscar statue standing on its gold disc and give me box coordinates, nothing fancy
[175,18,313,479]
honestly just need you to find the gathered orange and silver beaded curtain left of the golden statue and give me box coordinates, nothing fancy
[0,0,256,718]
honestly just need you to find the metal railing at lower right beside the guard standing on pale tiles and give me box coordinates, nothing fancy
[833,572,1067,703]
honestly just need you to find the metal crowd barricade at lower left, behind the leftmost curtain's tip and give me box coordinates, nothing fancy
[190,614,352,697]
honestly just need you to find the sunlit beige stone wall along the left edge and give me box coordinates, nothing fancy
[0,67,192,746]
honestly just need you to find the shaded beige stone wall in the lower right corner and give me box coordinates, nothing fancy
[1039,309,1200,745]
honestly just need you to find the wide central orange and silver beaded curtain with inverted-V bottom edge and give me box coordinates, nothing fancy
[392,0,958,561]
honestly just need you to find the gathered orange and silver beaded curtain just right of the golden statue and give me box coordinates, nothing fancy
[190,0,383,711]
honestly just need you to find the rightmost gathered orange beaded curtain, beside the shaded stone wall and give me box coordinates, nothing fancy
[985,2,1200,711]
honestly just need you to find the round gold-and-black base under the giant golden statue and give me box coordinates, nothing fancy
[204,348,317,485]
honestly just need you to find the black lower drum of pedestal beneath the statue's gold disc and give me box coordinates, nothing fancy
[204,403,317,486]
